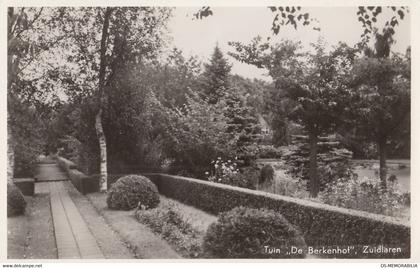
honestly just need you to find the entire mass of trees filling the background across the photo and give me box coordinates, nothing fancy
[8,7,410,203]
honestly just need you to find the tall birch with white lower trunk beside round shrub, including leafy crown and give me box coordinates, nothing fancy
[54,7,171,191]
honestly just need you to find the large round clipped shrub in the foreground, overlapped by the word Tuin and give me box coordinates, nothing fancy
[203,207,306,258]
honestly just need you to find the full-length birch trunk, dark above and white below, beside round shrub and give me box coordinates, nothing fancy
[95,7,112,192]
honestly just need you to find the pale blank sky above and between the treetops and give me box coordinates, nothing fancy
[169,7,410,80]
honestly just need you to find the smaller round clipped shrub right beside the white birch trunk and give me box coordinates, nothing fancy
[106,175,159,210]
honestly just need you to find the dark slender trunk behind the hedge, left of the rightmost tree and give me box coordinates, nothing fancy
[309,133,319,197]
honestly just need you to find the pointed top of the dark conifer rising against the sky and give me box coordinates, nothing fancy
[202,45,232,104]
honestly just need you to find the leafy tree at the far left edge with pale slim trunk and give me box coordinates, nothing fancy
[7,7,63,181]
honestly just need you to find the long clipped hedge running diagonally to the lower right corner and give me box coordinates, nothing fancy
[144,174,410,258]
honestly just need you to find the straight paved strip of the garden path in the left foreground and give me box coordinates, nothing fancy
[49,181,104,259]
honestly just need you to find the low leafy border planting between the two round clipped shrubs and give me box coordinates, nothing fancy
[136,204,202,258]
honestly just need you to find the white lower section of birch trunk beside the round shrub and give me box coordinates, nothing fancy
[95,109,108,192]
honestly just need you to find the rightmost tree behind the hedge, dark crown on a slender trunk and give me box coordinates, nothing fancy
[353,28,411,188]
